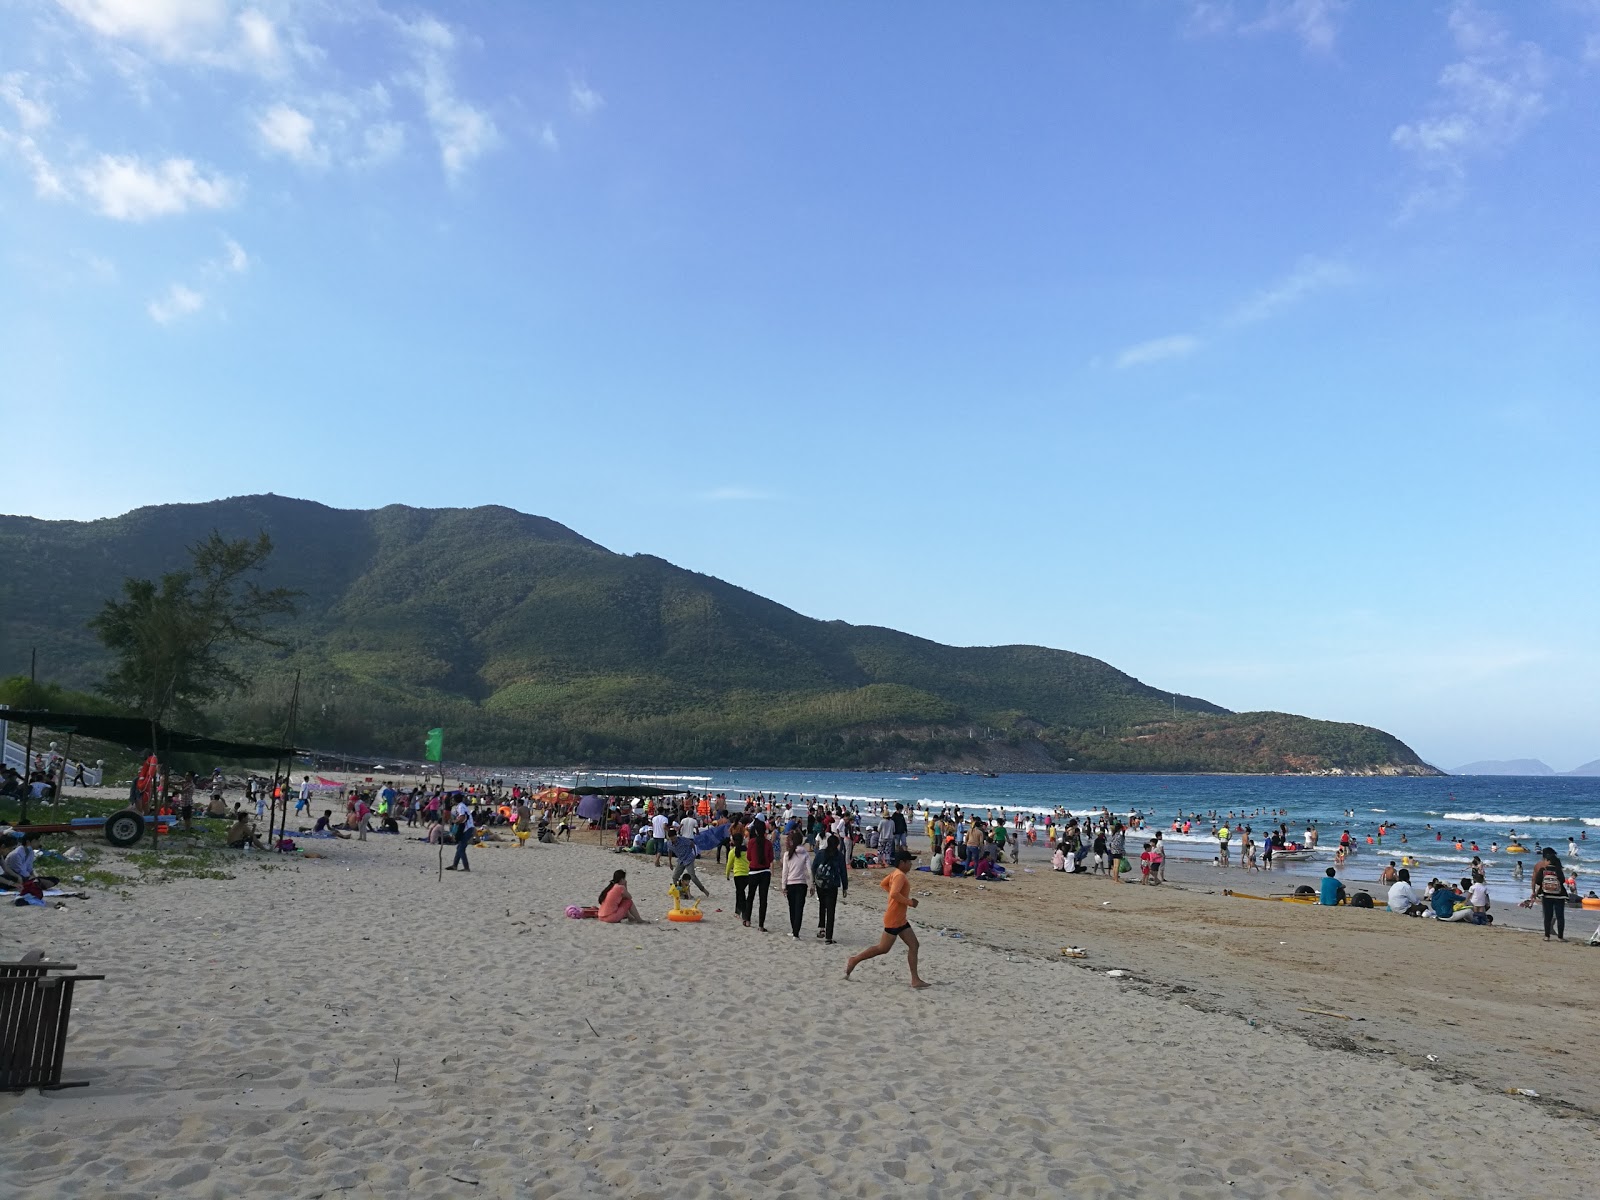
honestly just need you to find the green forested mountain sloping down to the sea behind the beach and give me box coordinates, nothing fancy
[0,496,1434,774]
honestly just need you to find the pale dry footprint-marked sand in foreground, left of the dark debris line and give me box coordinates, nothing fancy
[0,837,1600,1198]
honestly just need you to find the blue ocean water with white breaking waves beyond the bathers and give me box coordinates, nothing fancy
[547,770,1600,894]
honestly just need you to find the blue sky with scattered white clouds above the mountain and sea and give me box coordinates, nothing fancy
[0,0,1600,770]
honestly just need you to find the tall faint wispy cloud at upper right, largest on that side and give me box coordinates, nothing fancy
[1390,0,1550,218]
